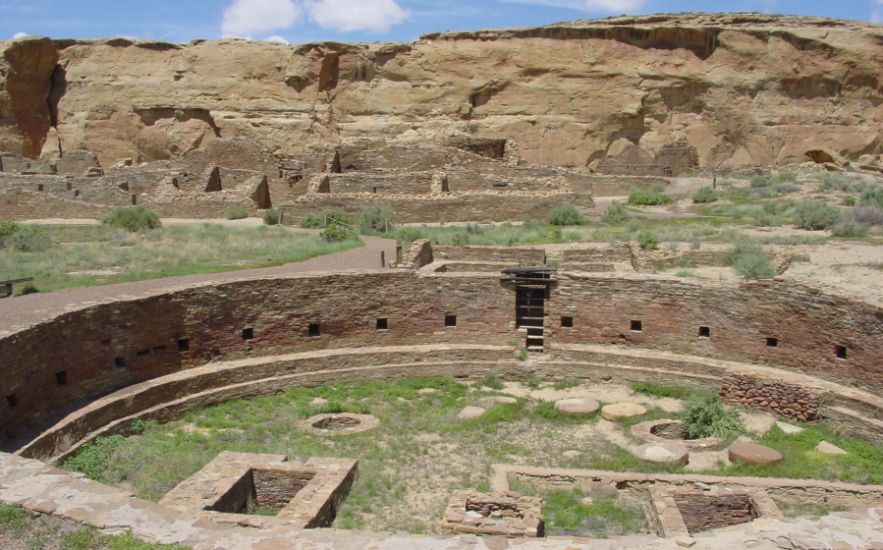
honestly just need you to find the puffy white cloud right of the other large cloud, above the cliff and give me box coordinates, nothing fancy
[304,0,408,32]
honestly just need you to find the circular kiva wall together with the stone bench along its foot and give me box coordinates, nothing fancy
[0,270,883,457]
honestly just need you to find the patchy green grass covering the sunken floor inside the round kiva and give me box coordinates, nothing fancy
[64,377,883,533]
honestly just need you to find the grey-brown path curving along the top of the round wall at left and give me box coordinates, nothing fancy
[0,233,396,336]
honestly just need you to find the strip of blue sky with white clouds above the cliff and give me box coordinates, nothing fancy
[0,0,883,43]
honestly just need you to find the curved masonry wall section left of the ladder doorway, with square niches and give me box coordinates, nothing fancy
[0,272,515,448]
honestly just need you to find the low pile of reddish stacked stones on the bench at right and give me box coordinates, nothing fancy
[720,374,824,422]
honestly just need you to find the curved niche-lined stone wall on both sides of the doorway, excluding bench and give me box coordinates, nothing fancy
[0,271,883,449]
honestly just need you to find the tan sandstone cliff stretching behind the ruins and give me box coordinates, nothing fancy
[0,14,883,168]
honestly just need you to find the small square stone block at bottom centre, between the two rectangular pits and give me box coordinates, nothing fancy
[441,491,545,538]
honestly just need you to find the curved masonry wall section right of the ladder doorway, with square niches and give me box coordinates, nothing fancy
[546,274,883,391]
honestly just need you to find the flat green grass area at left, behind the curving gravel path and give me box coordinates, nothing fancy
[0,224,360,292]
